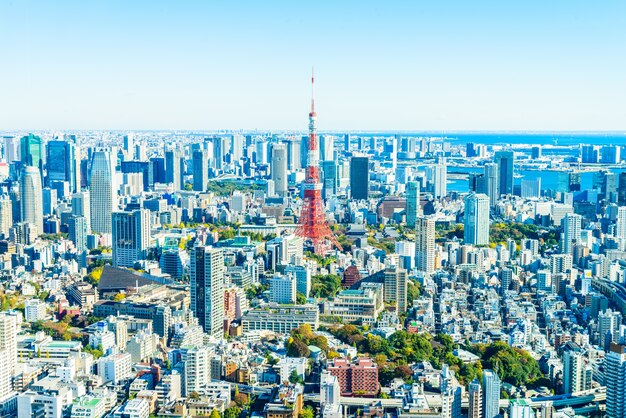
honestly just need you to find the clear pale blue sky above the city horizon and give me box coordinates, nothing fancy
[0,0,626,130]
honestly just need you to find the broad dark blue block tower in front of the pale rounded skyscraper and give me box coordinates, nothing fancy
[112,209,150,267]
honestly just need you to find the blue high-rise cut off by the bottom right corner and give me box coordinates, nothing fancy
[604,343,626,418]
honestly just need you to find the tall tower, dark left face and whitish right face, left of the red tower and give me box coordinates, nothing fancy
[190,246,225,337]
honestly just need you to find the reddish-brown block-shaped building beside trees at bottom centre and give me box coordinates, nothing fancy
[327,357,379,396]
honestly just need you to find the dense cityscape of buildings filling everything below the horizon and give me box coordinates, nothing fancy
[0,58,626,418]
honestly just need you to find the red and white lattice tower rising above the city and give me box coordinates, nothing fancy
[296,69,341,255]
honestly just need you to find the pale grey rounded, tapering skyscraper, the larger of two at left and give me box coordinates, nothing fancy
[89,149,117,234]
